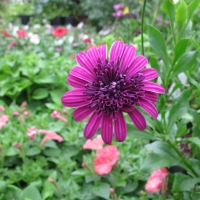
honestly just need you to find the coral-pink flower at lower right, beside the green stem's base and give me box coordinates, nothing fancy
[145,168,168,193]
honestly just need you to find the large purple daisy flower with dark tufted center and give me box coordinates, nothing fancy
[61,41,165,144]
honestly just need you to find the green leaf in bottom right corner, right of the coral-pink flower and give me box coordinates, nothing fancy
[172,173,200,192]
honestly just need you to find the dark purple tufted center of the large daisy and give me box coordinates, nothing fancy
[84,59,145,118]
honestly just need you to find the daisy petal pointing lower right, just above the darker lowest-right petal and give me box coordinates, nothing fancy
[138,99,158,118]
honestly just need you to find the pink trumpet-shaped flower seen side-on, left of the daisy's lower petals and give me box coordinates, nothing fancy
[39,129,63,147]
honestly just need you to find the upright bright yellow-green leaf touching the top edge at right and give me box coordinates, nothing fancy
[176,1,187,35]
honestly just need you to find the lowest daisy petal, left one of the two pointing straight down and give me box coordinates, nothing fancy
[101,115,113,144]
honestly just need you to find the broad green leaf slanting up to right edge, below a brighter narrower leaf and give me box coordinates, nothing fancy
[172,51,198,77]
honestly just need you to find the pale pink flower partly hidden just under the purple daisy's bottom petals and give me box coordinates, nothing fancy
[83,135,104,150]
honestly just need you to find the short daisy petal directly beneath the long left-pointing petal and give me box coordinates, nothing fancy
[73,105,93,122]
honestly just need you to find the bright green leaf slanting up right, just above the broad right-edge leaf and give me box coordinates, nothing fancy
[173,39,190,64]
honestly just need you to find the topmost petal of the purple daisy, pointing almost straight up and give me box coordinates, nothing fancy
[110,41,126,61]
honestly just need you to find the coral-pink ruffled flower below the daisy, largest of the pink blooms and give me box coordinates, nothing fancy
[93,145,119,175]
